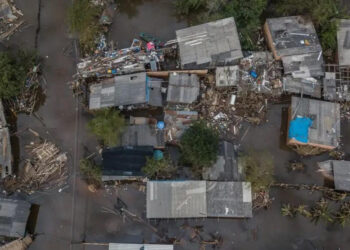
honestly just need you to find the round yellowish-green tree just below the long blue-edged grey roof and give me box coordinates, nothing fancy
[88,109,125,146]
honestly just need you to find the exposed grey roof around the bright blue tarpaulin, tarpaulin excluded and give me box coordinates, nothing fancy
[291,96,340,147]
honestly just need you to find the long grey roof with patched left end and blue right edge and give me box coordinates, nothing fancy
[89,73,149,109]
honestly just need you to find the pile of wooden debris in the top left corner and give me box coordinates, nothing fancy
[0,0,24,41]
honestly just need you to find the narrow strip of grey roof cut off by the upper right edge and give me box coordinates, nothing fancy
[337,19,350,67]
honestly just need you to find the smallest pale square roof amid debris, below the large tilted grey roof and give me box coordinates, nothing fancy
[215,65,240,87]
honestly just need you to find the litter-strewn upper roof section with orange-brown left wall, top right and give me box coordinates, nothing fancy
[266,16,322,57]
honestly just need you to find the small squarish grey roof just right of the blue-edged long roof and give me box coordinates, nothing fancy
[167,73,199,104]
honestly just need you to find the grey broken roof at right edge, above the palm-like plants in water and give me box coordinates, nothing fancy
[318,160,350,192]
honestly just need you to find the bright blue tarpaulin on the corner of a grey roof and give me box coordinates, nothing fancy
[288,117,312,143]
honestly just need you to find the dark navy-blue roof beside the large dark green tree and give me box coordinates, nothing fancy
[102,146,153,181]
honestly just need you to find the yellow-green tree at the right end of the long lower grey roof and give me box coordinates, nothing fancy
[239,150,274,192]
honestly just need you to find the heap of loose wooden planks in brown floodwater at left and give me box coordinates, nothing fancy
[5,141,68,194]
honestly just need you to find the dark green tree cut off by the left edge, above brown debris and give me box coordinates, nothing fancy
[0,51,38,99]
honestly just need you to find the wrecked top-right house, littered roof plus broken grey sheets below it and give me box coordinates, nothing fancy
[264,16,324,98]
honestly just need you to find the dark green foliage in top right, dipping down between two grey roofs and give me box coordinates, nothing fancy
[270,0,347,54]
